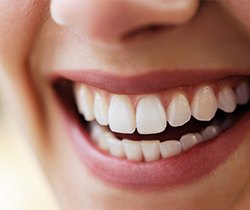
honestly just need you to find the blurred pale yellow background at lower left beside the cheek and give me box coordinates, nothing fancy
[0,97,59,210]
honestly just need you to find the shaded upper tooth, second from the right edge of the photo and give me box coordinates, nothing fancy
[218,87,237,113]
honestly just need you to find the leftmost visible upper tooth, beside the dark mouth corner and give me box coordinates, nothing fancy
[75,84,95,121]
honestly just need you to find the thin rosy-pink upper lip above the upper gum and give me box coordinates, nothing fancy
[49,69,249,94]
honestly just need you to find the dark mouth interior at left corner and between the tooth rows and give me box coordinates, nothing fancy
[53,79,250,141]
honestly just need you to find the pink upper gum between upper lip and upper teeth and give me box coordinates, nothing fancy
[78,77,248,108]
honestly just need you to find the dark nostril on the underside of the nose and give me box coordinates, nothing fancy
[121,24,176,41]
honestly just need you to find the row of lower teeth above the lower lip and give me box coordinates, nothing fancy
[90,118,233,162]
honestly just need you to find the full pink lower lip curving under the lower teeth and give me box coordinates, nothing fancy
[64,106,250,191]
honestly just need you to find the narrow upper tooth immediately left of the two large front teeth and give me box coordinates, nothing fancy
[94,93,108,125]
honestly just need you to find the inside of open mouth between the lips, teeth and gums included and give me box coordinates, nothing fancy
[55,77,250,161]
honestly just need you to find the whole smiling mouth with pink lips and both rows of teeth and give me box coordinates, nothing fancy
[52,70,250,189]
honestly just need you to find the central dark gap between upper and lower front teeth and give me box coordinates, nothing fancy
[113,118,211,141]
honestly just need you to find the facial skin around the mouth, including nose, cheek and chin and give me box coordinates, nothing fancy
[0,0,250,210]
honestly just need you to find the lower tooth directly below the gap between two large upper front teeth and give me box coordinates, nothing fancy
[122,139,143,161]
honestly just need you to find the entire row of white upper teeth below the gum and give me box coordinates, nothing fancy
[74,81,250,134]
